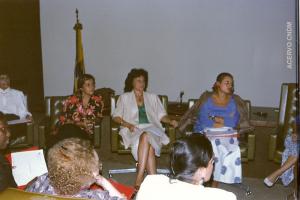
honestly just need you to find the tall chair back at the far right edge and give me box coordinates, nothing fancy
[276,83,296,151]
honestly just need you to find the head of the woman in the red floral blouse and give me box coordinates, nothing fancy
[78,74,96,96]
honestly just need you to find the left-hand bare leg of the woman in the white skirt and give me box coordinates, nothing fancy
[135,132,150,186]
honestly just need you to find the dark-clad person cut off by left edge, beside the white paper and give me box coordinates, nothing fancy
[0,112,17,192]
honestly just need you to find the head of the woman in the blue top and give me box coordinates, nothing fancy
[212,72,234,94]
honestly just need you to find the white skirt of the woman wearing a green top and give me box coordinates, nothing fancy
[119,124,170,161]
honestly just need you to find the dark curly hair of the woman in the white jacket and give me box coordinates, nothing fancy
[124,68,148,92]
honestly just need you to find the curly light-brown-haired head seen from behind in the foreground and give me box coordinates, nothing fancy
[47,138,100,195]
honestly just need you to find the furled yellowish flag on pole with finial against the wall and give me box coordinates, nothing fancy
[73,9,85,93]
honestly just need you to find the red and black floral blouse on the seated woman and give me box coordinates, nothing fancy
[57,95,104,134]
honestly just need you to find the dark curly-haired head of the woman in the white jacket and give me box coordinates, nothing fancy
[124,68,148,92]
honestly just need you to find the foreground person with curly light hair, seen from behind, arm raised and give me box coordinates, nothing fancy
[26,138,125,200]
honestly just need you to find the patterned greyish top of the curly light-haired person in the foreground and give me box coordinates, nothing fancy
[26,173,120,200]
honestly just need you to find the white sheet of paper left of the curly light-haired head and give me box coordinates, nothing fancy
[11,150,48,186]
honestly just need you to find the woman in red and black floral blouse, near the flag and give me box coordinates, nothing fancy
[57,74,104,135]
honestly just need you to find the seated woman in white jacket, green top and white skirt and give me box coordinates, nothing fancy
[113,69,177,189]
